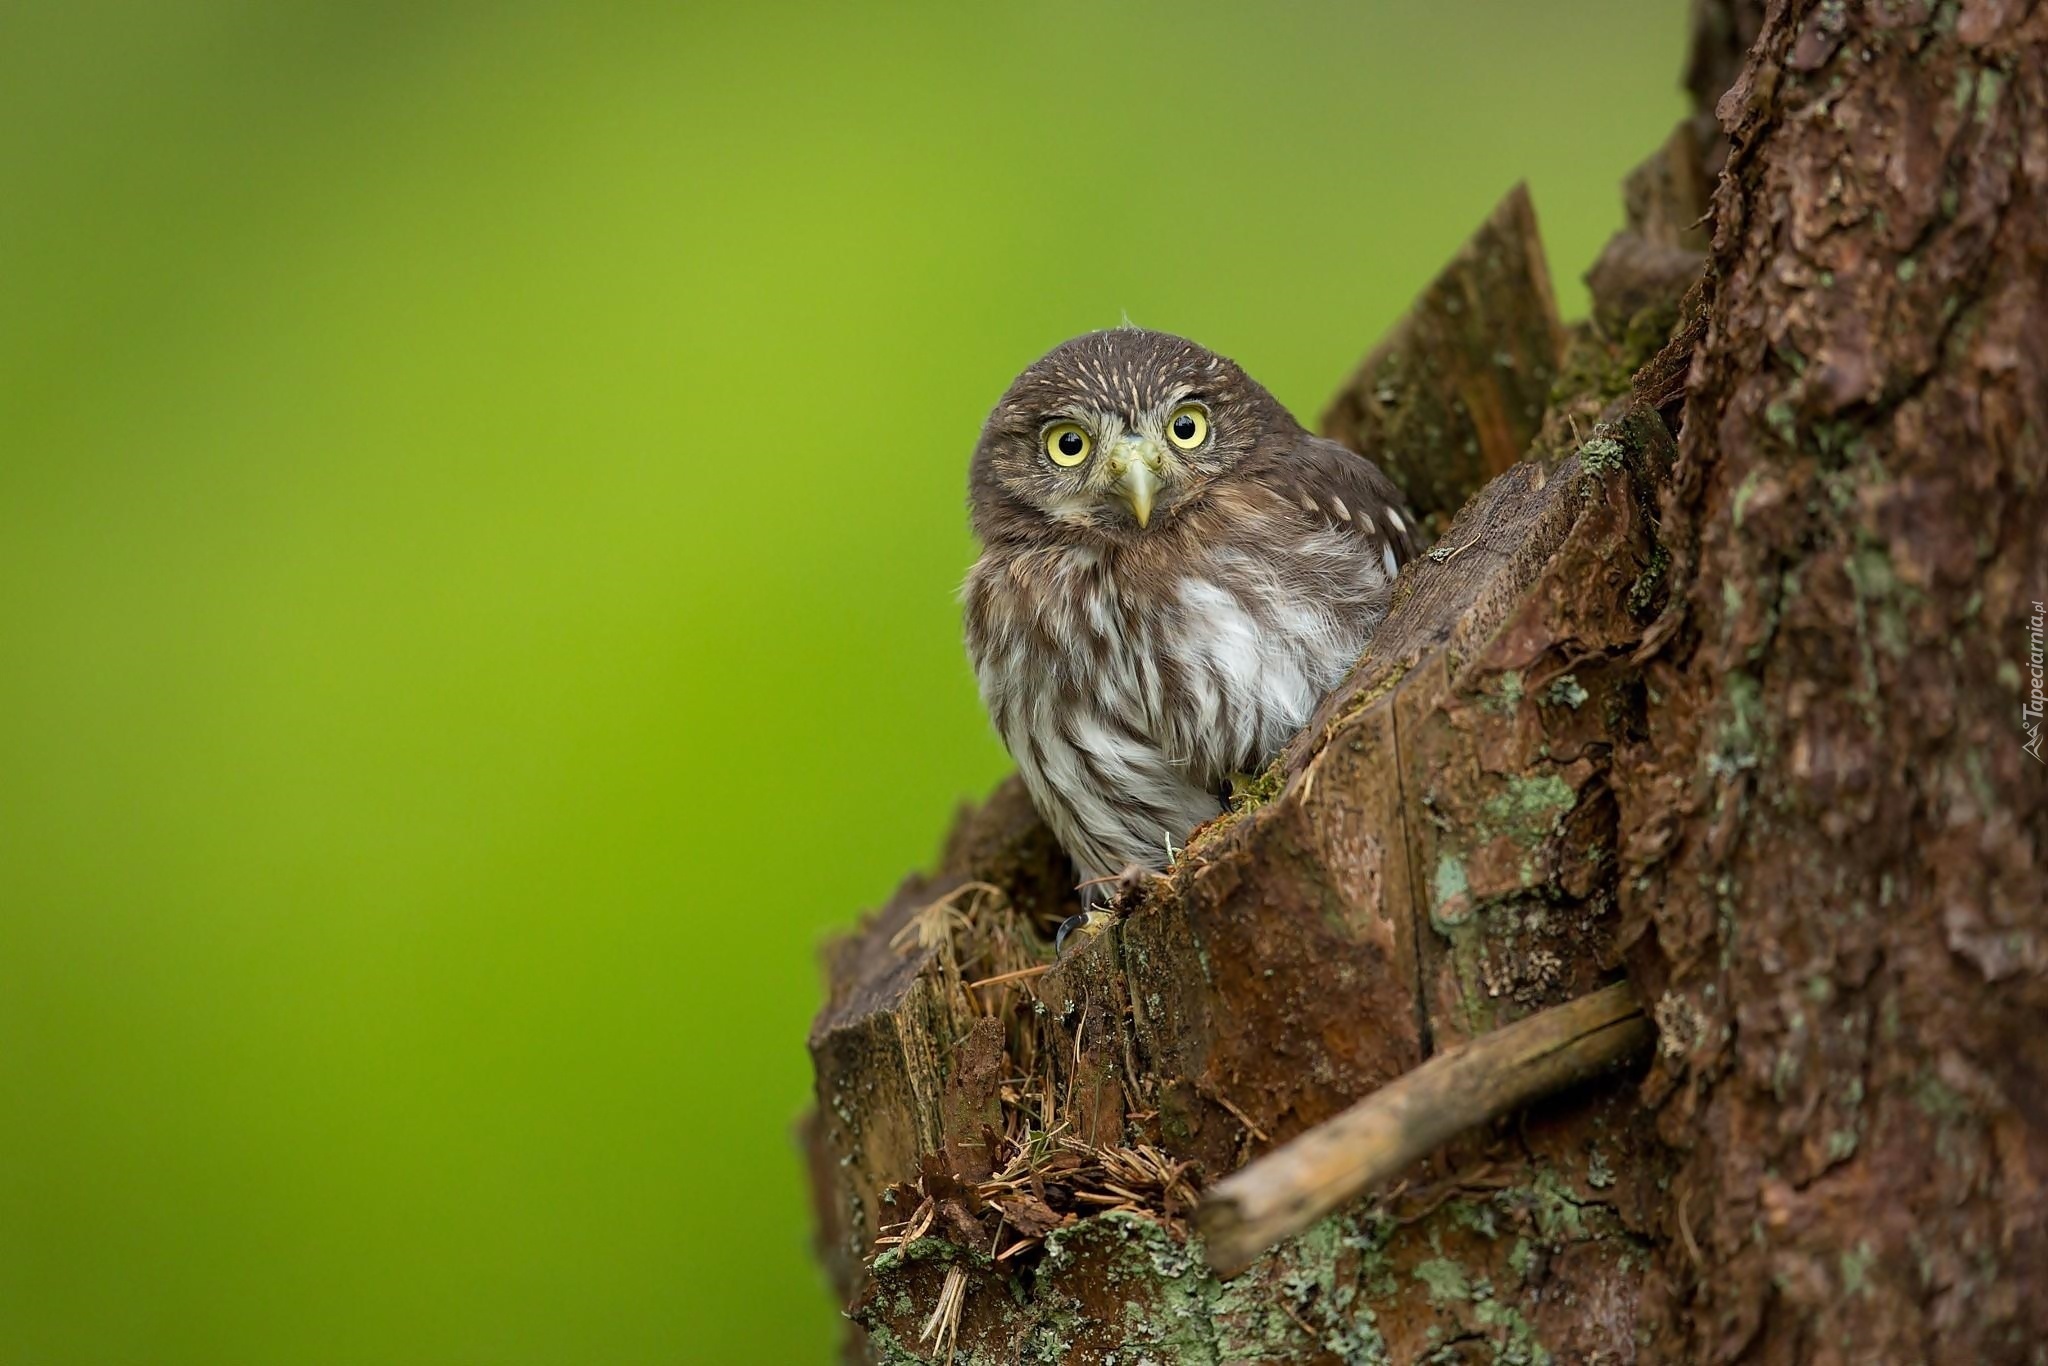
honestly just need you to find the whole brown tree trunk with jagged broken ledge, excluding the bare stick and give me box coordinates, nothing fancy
[807,0,2048,1362]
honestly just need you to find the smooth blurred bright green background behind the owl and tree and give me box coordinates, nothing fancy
[0,0,1683,1362]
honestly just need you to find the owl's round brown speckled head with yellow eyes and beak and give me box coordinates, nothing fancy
[967,328,1300,545]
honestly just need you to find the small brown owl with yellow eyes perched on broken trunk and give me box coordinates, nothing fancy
[963,328,1417,901]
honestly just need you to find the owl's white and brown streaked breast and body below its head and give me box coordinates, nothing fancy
[967,535,1389,879]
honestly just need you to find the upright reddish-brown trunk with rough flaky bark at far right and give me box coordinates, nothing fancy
[1616,0,2048,1362]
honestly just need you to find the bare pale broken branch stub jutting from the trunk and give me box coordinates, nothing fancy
[1196,981,1655,1276]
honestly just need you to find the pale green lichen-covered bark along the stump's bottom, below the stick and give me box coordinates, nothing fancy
[858,1163,1642,1366]
